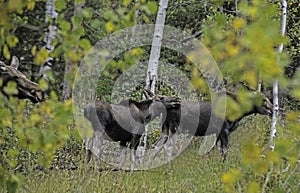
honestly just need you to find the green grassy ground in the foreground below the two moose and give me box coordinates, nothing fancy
[7,116,299,193]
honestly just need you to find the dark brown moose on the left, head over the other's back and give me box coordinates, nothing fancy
[84,94,179,172]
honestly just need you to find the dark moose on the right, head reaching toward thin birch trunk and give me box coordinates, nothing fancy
[148,88,273,166]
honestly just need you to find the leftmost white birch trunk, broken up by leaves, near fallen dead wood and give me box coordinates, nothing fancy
[40,0,58,80]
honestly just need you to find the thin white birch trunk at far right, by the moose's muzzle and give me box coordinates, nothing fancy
[269,0,287,150]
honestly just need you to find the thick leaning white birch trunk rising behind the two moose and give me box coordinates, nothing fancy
[139,0,168,157]
